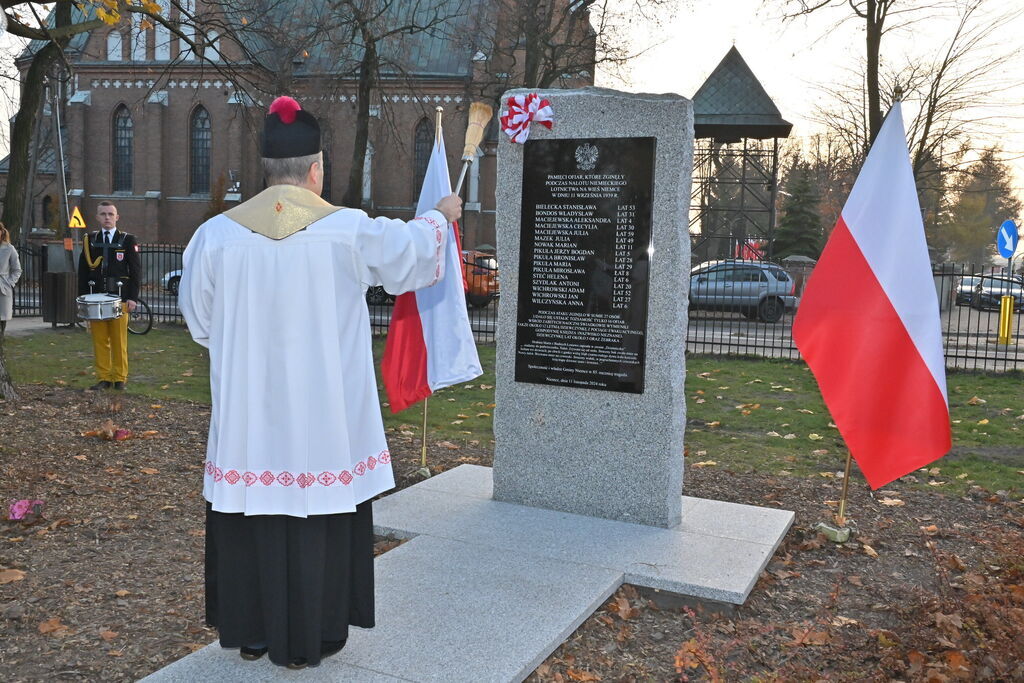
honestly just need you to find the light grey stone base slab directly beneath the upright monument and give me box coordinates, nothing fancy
[374,465,794,604]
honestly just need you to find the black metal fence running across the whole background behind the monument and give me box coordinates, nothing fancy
[14,245,1024,372]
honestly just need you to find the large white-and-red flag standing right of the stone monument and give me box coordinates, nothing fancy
[793,102,951,488]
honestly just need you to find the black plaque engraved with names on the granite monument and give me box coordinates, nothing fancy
[515,137,655,393]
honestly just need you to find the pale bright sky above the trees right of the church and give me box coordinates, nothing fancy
[596,0,1024,208]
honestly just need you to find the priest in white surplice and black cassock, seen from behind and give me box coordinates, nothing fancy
[178,97,462,669]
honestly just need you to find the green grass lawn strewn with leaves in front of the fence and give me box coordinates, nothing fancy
[6,327,1024,494]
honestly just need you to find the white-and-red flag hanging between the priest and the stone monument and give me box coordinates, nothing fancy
[381,136,483,413]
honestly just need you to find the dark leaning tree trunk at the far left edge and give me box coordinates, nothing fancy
[0,43,60,243]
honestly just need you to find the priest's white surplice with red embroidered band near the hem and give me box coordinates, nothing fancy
[179,190,447,517]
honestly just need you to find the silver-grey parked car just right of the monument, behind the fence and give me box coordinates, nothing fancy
[690,259,797,323]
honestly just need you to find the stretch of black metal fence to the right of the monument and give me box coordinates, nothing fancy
[686,264,1024,372]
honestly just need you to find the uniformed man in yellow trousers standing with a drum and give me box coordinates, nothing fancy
[78,202,142,391]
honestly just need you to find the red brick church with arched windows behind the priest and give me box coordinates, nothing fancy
[0,0,593,248]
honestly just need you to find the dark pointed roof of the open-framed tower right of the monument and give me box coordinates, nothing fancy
[693,46,793,142]
